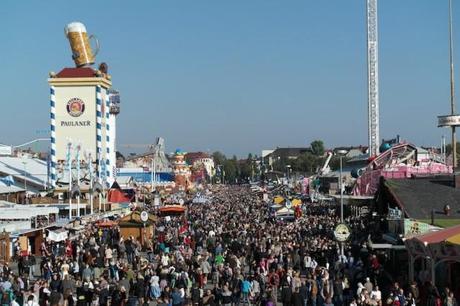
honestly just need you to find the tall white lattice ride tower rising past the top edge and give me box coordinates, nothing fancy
[367,0,380,156]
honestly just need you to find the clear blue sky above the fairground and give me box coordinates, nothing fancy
[0,0,460,156]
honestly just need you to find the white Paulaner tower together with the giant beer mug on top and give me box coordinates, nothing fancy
[48,22,120,190]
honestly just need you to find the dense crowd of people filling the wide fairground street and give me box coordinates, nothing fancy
[0,186,457,306]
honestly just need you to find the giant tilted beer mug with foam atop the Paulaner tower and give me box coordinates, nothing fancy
[64,22,99,67]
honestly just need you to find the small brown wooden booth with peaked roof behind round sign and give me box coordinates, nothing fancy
[118,211,156,244]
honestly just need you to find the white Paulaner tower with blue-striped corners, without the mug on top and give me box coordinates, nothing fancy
[48,67,119,187]
